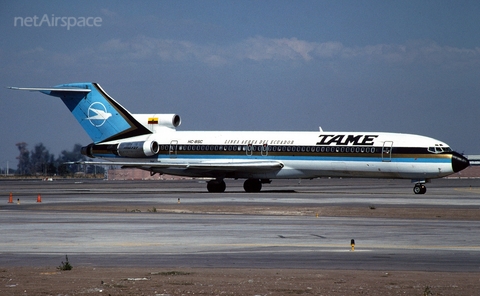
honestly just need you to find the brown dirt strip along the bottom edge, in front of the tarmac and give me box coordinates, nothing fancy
[0,266,480,296]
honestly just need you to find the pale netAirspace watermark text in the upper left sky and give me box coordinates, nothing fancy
[13,14,102,30]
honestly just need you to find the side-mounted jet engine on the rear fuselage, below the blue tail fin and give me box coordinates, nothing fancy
[81,141,160,158]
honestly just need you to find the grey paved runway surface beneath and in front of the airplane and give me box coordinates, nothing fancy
[0,179,480,272]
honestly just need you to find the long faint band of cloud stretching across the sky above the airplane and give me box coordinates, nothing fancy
[12,36,480,69]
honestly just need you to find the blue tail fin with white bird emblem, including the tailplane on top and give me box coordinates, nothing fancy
[10,83,152,143]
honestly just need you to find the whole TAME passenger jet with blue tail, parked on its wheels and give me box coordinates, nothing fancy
[9,83,470,194]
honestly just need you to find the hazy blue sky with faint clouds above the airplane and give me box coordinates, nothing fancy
[0,0,480,168]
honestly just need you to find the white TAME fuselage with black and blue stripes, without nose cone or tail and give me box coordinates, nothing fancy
[97,131,462,180]
